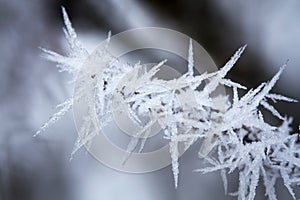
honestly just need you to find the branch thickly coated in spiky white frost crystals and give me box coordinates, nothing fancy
[35,8,300,200]
